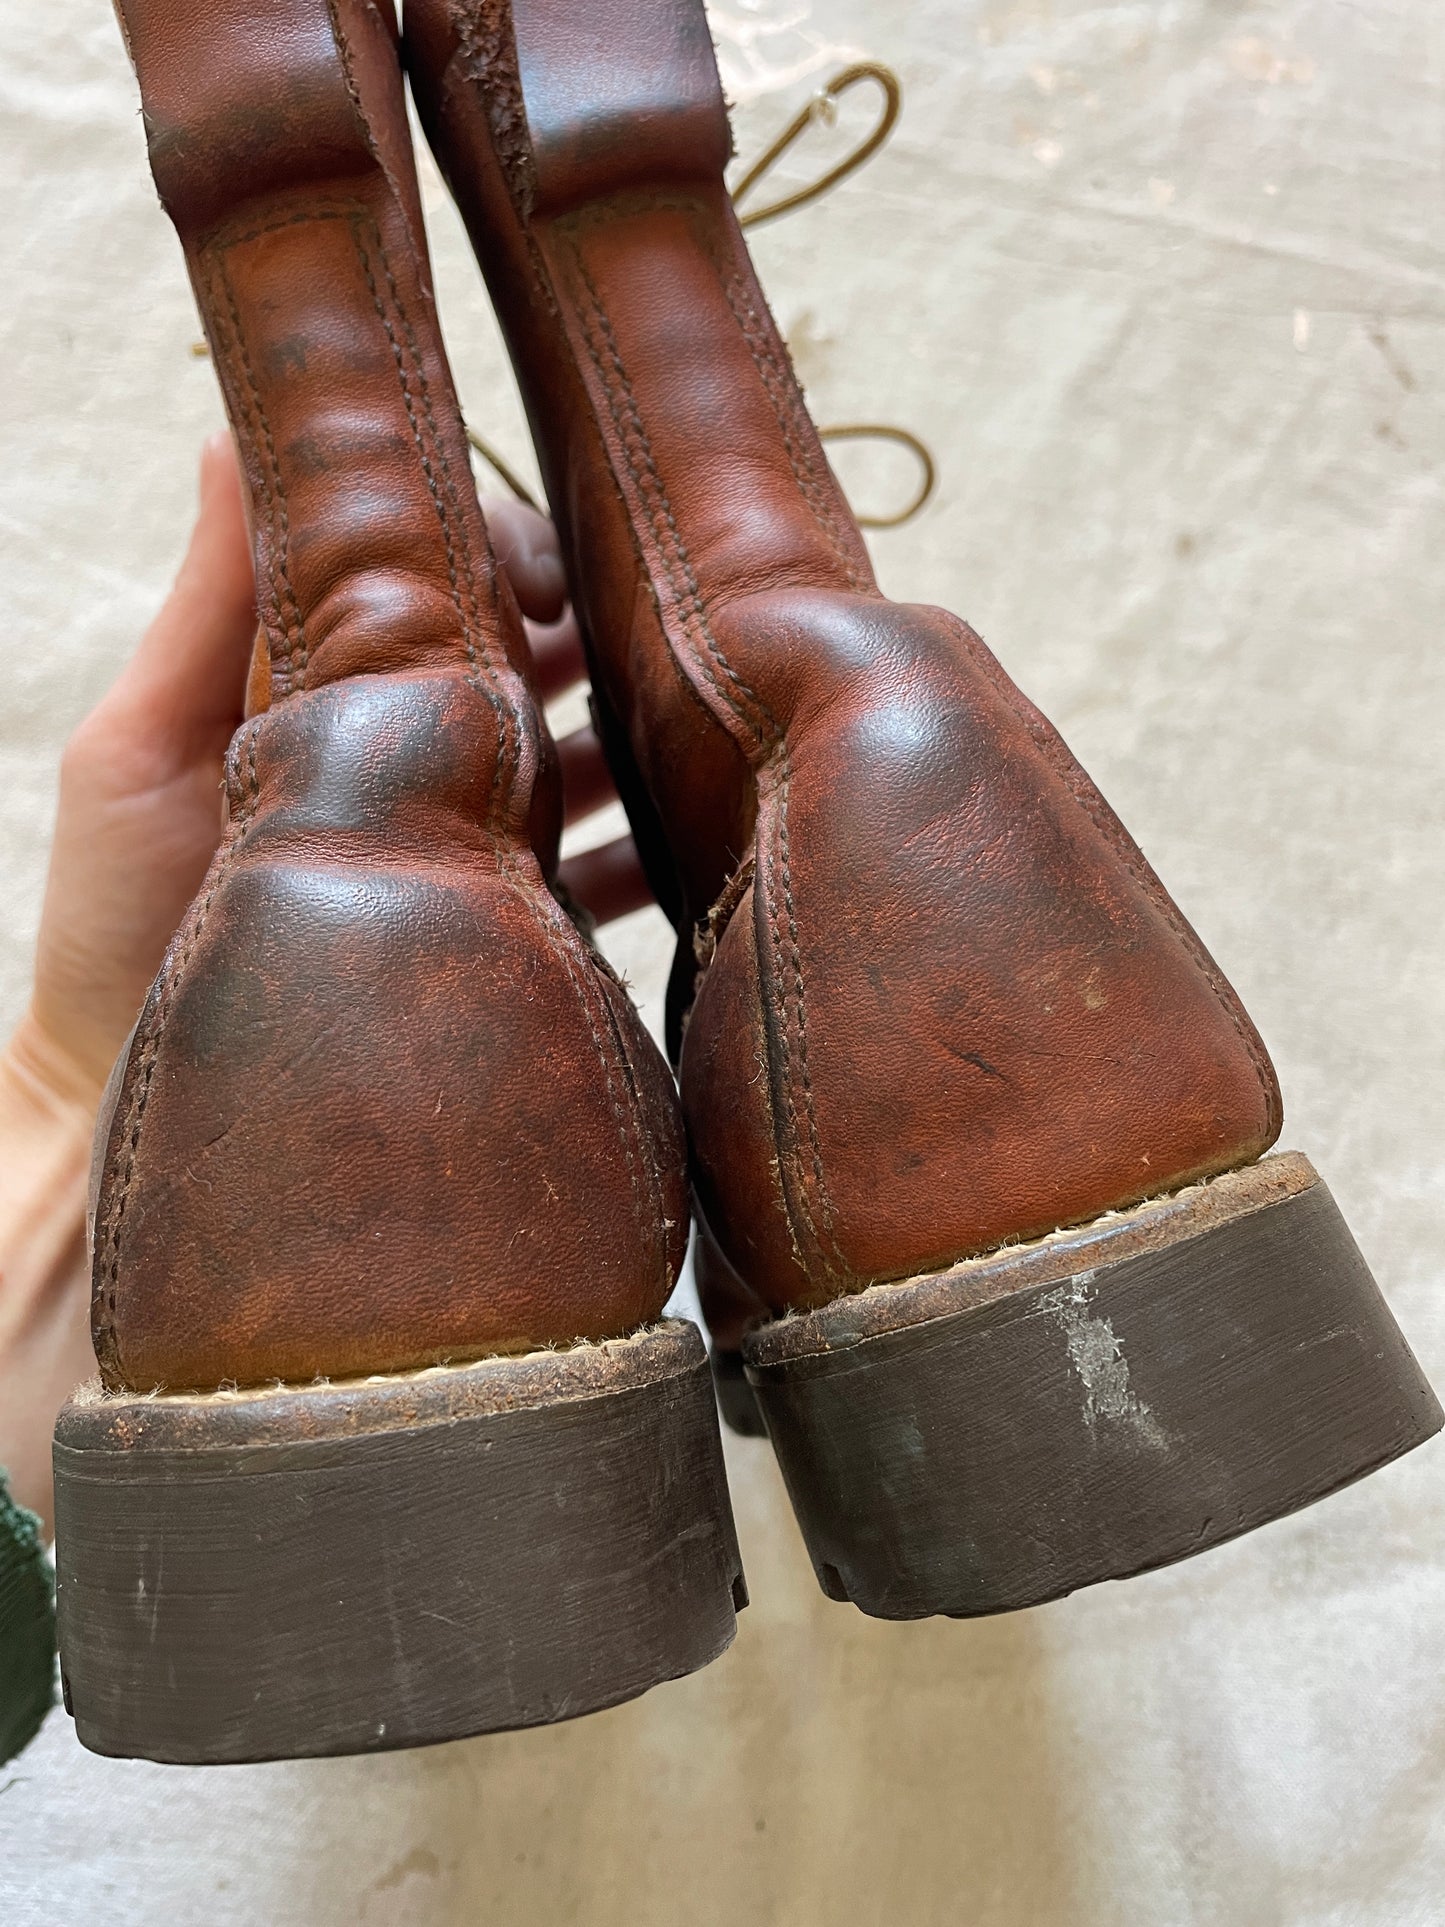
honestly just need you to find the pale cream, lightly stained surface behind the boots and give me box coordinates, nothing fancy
[0,0,1445,1927]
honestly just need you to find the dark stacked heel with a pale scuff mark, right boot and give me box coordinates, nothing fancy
[744,1154,1441,1619]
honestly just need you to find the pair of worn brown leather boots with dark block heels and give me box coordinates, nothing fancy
[56,0,1441,1761]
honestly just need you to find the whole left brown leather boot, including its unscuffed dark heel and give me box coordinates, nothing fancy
[56,0,744,1761]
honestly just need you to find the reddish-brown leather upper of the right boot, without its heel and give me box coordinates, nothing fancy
[405,0,1279,1308]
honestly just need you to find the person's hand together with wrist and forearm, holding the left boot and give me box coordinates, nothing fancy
[0,434,647,1517]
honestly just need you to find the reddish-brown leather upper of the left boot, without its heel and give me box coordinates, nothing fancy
[94,0,686,1389]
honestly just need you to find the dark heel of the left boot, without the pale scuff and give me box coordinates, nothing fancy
[56,1322,748,1763]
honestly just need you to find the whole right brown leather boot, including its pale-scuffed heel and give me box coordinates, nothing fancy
[405,0,1441,1619]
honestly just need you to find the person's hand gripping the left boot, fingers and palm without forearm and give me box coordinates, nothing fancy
[17,432,649,1096]
